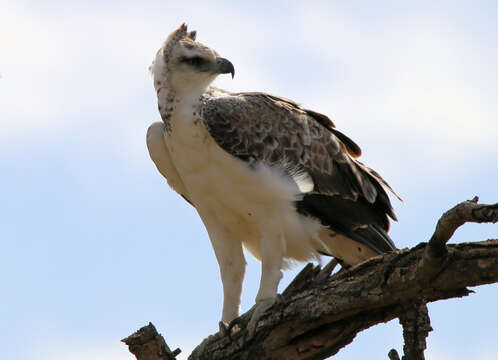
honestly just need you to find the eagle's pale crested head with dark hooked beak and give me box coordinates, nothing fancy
[150,24,235,96]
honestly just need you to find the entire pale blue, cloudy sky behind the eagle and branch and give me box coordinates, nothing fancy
[0,0,498,360]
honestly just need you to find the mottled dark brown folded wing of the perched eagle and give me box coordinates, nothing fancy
[202,93,395,252]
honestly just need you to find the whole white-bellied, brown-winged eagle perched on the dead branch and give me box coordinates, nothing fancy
[147,24,401,332]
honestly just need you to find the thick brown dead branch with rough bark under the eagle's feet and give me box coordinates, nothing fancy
[123,198,498,360]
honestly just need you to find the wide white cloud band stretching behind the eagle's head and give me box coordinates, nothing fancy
[0,3,498,177]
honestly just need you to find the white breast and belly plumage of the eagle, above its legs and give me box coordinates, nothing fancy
[154,109,375,268]
